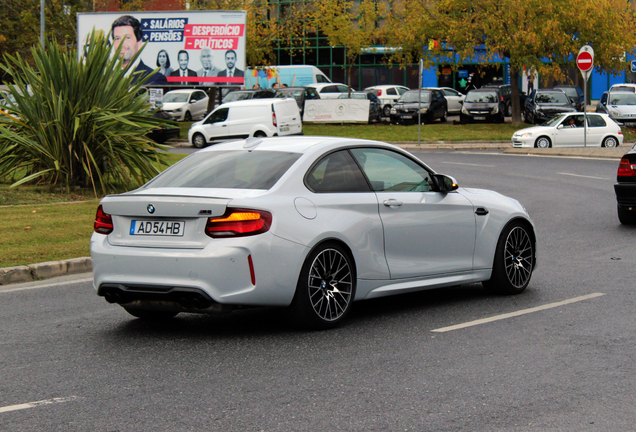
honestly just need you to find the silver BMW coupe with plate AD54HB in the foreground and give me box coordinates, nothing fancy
[91,136,537,328]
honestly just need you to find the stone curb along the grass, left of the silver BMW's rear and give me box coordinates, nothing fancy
[0,257,93,285]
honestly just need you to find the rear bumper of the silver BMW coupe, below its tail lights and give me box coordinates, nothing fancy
[91,233,308,306]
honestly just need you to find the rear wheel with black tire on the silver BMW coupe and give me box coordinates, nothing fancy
[291,242,356,330]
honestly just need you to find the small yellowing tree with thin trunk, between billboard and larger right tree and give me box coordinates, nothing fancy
[312,0,380,93]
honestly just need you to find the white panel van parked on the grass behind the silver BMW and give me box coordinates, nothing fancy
[188,99,303,148]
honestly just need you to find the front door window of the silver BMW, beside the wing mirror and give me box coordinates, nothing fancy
[351,148,432,192]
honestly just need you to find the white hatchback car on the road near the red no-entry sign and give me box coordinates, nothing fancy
[512,113,623,148]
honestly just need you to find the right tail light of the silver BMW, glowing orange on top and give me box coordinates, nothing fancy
[205,209,272,238]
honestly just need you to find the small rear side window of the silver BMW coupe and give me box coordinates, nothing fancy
[305,150,371,193]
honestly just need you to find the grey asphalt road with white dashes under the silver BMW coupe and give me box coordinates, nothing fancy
[0,151,636,432]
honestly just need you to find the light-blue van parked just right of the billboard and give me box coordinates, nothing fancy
[245,65,331,89]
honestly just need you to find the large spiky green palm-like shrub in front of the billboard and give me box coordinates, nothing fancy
[0,33,170,192]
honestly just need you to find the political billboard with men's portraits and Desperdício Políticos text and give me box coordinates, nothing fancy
[77,10,247,87]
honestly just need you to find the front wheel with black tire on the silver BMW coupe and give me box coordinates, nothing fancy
[482,221,535,294]
